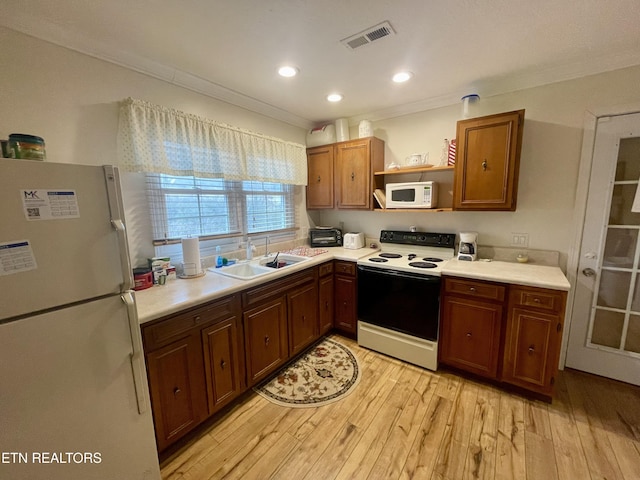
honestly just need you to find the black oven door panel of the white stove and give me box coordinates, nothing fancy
[358,265,440,342]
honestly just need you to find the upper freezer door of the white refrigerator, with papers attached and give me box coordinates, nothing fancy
[0,159,131,320]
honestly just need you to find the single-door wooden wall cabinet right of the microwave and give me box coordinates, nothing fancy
[453,110,524,211]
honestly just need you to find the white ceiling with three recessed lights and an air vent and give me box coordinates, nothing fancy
[0,0,640,128]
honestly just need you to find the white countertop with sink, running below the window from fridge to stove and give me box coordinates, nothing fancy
[135,247,377,324]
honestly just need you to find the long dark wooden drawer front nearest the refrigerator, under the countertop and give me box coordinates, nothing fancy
[142,295,240,350]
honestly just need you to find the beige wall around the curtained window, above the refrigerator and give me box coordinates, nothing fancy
[0,27,306,265]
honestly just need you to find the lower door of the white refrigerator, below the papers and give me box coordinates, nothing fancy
[0,295,160,480]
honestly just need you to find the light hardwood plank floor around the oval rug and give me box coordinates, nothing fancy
[162,336,640,480]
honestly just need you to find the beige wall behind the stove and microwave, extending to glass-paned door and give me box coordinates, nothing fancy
[318,67,640,266]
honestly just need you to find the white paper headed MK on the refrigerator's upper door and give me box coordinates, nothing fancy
[20,188,80,221]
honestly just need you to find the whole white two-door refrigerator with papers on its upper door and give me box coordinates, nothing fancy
[0,159,160,480]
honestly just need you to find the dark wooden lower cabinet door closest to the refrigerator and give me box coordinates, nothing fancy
[147,335,207,450]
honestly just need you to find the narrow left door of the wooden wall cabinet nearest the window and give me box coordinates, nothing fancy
[307,145,334,209]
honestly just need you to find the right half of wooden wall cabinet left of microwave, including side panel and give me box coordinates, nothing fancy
[335,137,384,210]
